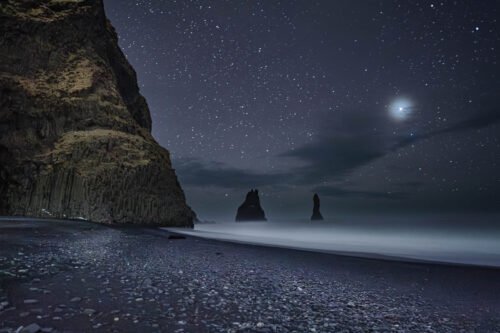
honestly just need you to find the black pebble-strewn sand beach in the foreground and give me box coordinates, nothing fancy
[0,219,500,332]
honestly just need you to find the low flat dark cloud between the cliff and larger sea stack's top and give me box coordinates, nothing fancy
[175,159,288,188]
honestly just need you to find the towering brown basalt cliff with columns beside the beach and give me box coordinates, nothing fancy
[0,0,194,226]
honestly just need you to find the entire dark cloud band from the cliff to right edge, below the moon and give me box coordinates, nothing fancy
[174,106,500,191]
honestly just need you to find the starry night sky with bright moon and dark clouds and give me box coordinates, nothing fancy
[104,0,500,219]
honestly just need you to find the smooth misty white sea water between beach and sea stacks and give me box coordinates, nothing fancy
[168,214,500,267]
